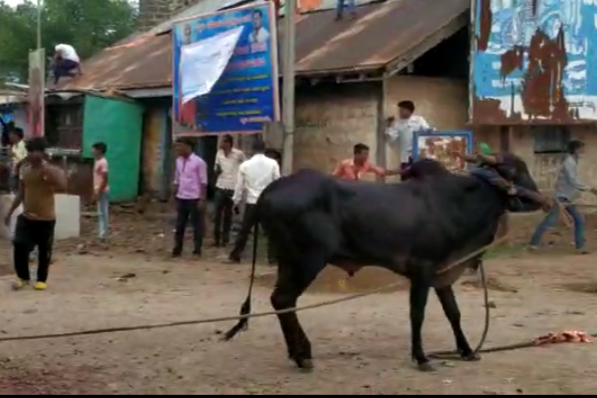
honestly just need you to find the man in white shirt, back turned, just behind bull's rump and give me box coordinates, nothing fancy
[229,140,280,263]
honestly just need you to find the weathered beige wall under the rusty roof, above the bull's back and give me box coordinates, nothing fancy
[294,76,468,180]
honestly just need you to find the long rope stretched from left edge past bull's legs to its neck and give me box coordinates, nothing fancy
[0,236,507,345]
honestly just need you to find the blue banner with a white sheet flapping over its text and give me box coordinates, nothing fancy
[172,2,280,136]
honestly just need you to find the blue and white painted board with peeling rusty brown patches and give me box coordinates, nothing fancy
[471,0,597,124]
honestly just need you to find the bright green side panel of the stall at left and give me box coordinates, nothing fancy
[83,95,143,202]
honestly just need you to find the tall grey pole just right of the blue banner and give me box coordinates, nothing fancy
[282,0,297,175]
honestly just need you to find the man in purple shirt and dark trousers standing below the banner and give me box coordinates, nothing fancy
[172,138,207,257]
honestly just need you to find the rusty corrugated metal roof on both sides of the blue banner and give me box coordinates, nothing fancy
[58,0,470,90]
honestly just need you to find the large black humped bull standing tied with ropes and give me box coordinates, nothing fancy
[226,156,539,370]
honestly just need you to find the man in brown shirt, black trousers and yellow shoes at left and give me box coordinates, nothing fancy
[4,137,67,290]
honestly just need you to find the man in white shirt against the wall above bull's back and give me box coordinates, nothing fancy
[386,101,430,181]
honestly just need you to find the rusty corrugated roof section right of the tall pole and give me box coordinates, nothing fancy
[280,0,470,74]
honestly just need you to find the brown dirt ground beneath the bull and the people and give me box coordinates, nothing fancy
[0,210,597,395]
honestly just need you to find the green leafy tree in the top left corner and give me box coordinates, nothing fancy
[0,0,137,82]
